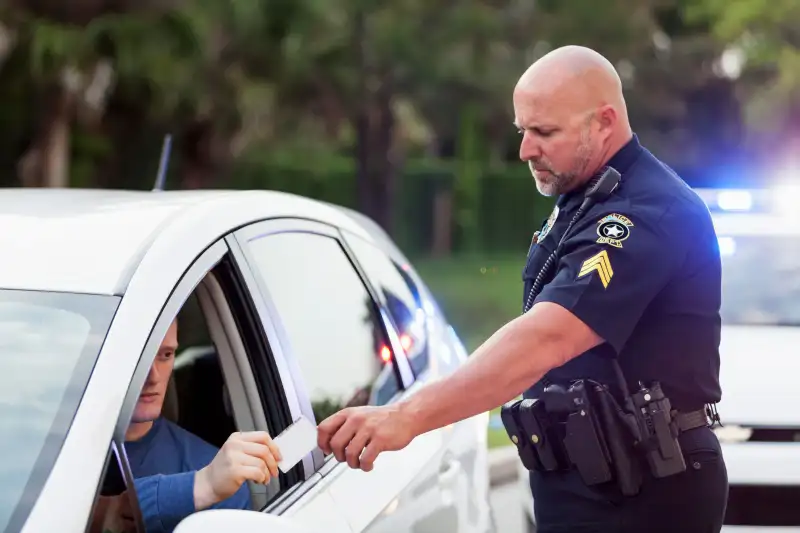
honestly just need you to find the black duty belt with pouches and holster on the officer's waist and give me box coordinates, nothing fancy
[500,379,714,495]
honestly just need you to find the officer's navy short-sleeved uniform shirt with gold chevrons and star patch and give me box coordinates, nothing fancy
[523,135,721,411]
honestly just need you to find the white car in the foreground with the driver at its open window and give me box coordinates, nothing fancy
[0,189,494,533]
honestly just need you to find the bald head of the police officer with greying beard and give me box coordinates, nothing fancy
[513,46,632,196]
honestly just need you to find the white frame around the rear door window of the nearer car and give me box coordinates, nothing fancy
[231,217,414,478]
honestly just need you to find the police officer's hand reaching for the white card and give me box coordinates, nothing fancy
[317,405,416,472]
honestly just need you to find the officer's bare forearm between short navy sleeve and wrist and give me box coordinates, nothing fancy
[402,304,600,434]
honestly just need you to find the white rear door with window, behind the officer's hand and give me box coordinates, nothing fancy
[230,219,457,533]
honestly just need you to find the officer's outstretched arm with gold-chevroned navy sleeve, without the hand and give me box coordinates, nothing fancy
[401,205,686,434]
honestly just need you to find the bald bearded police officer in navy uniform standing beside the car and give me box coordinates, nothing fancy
[319,46,727,533]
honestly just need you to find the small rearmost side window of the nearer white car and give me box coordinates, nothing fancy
[347,236,429,376]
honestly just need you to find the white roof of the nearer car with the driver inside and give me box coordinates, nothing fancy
[0,188,373,295]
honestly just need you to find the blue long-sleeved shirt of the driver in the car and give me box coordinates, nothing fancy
[125,417,251,533]
